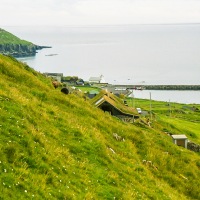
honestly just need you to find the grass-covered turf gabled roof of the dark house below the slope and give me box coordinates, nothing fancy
[91,91,139,116]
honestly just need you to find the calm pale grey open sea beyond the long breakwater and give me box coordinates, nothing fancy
[2,24,200,103]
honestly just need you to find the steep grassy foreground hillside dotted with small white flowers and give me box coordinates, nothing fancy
[0,55,200,200]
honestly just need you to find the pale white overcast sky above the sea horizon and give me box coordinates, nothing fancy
[0,0,200,26]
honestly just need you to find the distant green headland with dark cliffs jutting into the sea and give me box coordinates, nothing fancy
[0,28,49,57]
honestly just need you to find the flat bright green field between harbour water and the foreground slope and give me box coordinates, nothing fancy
[128,98,200,144]
